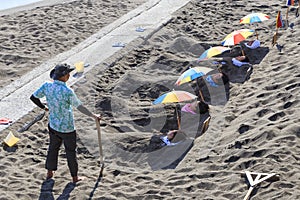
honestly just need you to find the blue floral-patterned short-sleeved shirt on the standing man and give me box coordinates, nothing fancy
[33,80,82,133]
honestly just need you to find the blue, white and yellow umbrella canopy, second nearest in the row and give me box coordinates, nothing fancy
[175,67,213,85]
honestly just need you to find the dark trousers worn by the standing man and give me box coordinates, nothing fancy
[46,125,78,177]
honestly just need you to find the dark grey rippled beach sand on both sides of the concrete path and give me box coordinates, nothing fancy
[0,0,300,200]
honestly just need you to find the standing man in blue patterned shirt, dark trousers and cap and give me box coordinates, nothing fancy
[30,64,100,183]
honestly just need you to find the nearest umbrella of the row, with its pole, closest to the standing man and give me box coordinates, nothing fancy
[153,90,197,129]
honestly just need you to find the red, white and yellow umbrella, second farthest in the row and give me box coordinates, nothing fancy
[221,29,254,46]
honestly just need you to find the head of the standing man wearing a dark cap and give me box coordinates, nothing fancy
[50,63,75,82]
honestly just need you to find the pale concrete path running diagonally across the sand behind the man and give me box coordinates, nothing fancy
[0,0,190,131]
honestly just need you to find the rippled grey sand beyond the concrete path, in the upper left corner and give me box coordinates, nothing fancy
[0,0,145,87]
